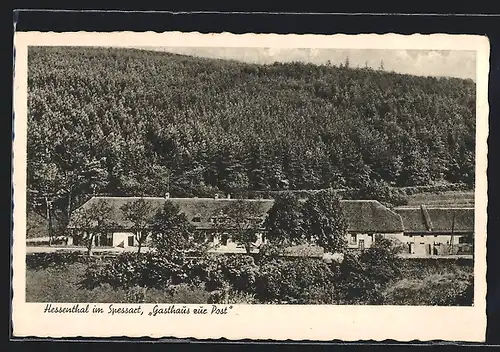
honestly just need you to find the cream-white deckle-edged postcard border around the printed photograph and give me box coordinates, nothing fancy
[12,32,489,342]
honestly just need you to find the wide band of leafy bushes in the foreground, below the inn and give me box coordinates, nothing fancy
[78,245,473,305]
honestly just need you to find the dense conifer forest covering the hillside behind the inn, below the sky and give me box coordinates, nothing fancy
[28,47,475,227]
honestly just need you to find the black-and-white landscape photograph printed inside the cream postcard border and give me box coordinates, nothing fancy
[11,31,486,340]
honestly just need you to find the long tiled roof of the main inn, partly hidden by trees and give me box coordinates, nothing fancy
[68,197,403,233]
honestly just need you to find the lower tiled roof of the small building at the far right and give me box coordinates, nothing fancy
[394,207,474,233]
